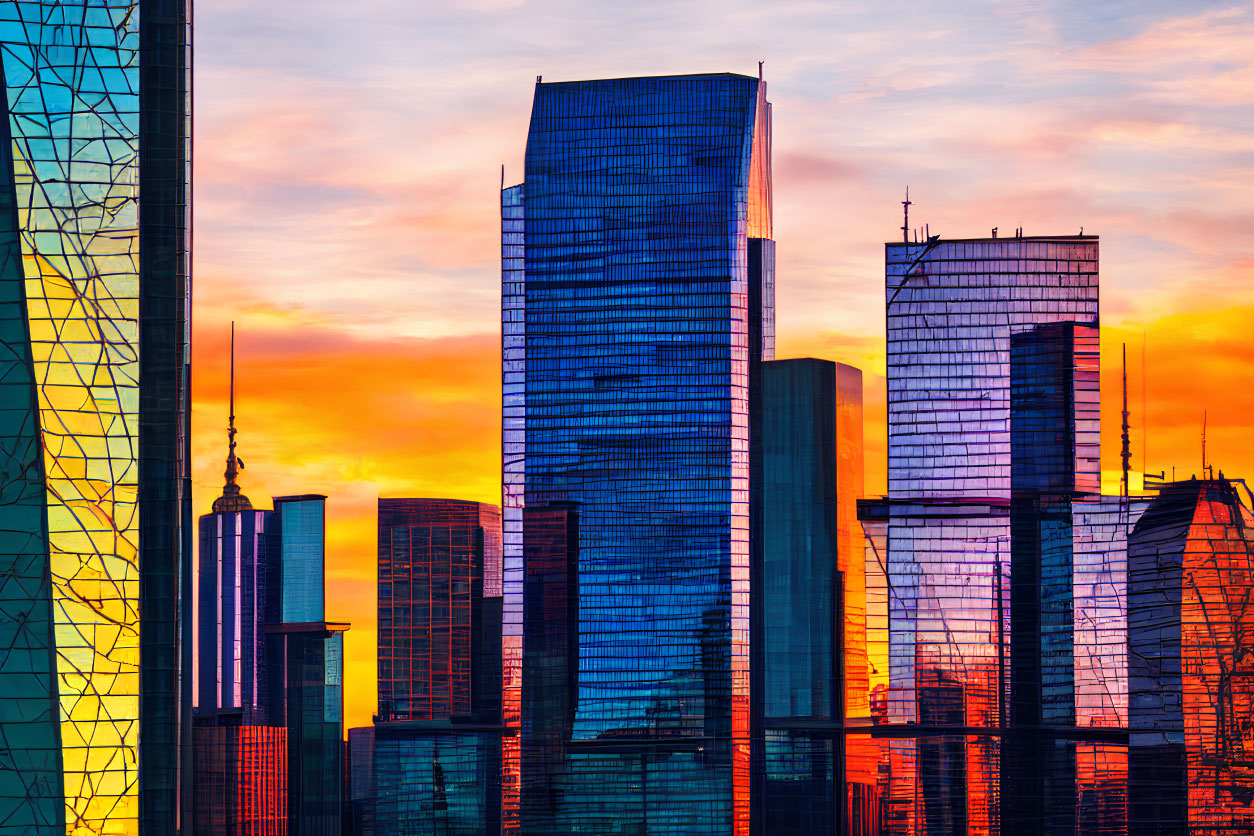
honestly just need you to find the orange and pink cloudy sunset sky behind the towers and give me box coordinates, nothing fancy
[192,0,1254,726]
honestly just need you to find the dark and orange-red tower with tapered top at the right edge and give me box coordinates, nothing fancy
[1127,474,1254,836]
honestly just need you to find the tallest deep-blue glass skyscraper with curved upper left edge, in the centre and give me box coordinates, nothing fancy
[502,74,774,833]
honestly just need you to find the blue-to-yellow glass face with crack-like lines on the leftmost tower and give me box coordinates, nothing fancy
[0,0,139,835]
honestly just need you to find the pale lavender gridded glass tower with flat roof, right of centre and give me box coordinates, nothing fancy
[884,236,1099,833]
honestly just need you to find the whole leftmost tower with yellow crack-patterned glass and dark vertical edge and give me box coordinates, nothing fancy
[0,0,192,836]
